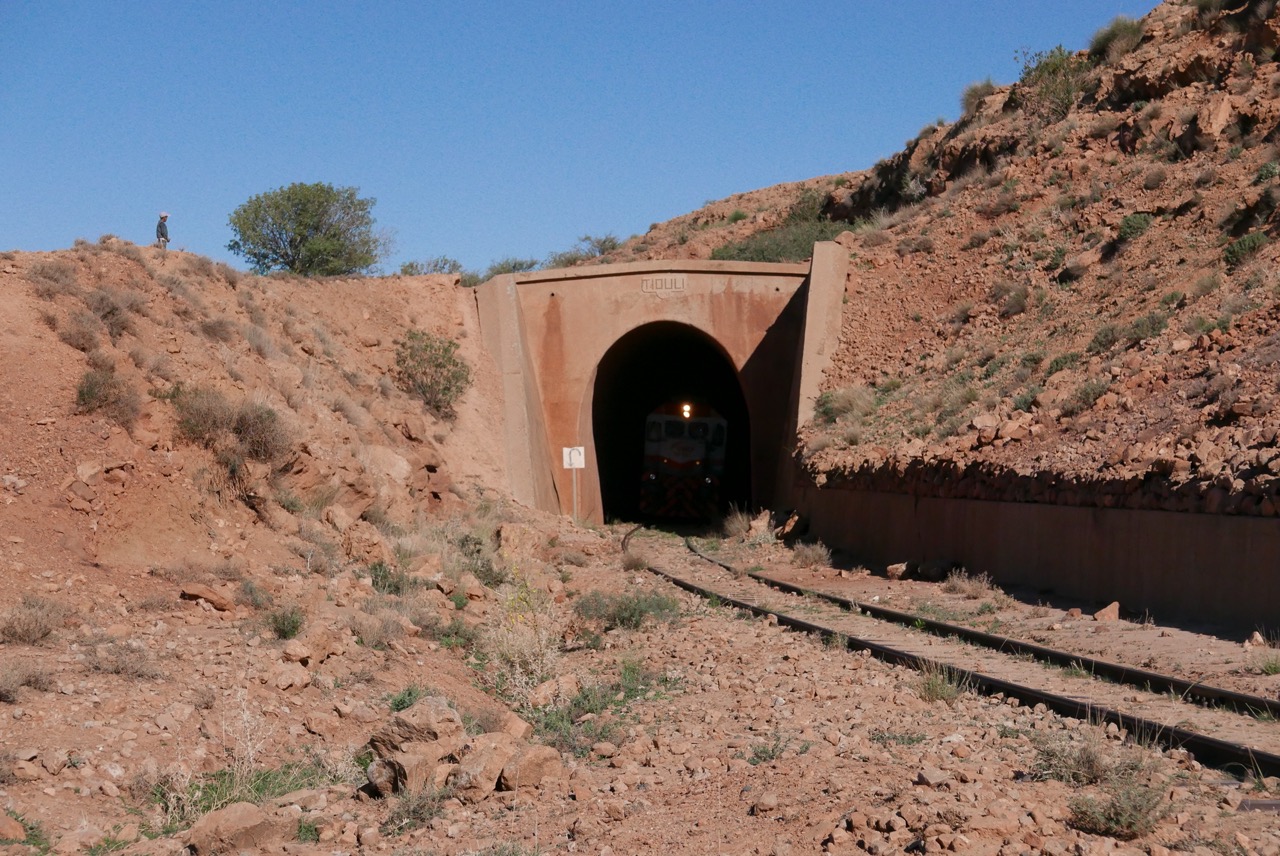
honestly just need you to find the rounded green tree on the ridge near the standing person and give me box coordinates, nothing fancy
[227,183,388,276]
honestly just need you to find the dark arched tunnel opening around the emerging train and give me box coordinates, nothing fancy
[591,321,751,522]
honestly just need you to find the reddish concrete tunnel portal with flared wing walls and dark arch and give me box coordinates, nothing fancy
[474,248,849,522]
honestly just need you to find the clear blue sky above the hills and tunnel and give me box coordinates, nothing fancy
[0,0,1157,271]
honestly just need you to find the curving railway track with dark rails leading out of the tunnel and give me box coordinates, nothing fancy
[623,527,1280,777]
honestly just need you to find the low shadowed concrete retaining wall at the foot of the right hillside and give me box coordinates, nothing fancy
[796,485,1280,632]
